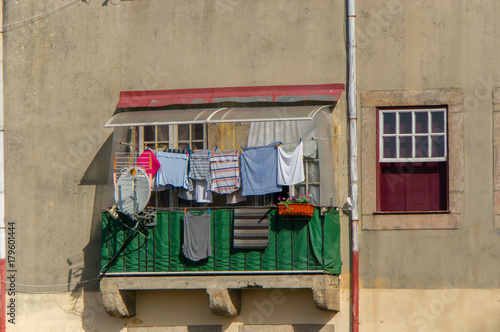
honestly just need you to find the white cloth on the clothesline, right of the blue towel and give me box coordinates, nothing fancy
[278,141,304,186]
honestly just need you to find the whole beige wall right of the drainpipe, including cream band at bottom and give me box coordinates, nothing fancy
[356,0,500,331]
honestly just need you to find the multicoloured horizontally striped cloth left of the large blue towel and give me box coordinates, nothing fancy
[210,151,241,194]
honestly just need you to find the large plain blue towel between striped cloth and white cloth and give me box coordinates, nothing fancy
[241,142,282,196]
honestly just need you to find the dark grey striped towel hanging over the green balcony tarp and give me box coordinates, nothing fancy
[233,208,269,249]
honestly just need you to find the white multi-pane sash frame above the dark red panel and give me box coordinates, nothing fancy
[378,108,448,163]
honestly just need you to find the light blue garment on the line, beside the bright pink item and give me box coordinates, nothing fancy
[156,152,188,189]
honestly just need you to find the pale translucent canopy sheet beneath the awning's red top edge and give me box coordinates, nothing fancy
[105,105,332,127]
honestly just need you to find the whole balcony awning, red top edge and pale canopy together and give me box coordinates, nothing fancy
[105,84,344,127]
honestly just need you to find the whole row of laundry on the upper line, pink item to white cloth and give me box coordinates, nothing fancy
[113,139,310,204]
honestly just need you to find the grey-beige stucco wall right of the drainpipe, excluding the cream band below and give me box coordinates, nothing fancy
[357,0,500,289]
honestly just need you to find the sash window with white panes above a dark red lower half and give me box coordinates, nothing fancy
[377,107,448,212]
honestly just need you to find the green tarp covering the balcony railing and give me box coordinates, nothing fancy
[101,209,341,274]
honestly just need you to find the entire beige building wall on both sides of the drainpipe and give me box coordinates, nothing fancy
[3,0,500,331]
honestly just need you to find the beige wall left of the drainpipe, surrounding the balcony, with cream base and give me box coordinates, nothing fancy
[4,0,349,331]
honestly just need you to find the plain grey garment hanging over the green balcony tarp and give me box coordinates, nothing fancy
[182,212,212,262]
